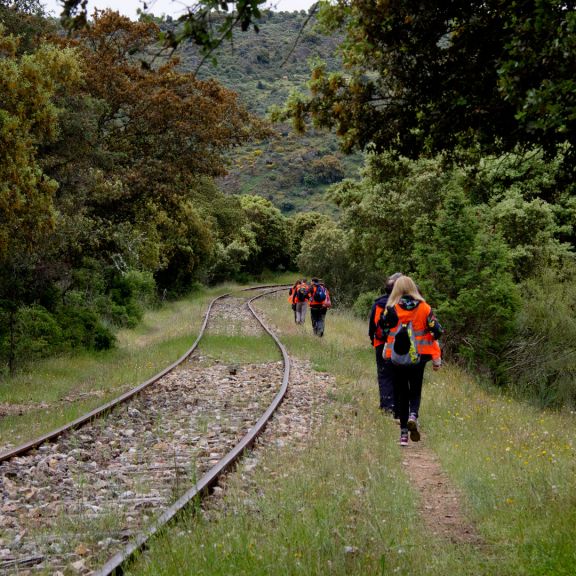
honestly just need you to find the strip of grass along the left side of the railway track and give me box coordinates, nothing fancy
[0,276,292,446]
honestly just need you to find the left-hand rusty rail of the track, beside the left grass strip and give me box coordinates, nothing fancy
[0,285,287,463]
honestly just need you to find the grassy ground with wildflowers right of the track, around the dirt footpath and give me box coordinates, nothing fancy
[131,297,576,576]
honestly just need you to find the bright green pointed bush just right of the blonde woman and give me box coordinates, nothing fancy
[414,178,519,372]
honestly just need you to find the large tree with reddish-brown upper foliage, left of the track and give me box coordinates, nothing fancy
[44,11,264,289]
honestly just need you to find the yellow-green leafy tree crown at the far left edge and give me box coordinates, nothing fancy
[0,28,80,262]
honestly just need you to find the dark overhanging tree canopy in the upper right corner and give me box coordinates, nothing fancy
[289,0,576,171]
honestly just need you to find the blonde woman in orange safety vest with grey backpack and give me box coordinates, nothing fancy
[379,276,443,446]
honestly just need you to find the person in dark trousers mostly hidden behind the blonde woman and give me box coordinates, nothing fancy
[368,272,402,415]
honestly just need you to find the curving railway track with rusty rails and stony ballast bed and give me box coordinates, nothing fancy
[0,287,290,576]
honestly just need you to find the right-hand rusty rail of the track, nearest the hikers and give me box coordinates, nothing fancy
[92,286,290,576]
